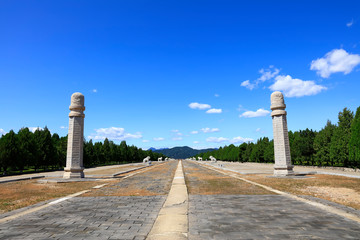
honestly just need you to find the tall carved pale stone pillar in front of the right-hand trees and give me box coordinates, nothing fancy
[270,92,294,176]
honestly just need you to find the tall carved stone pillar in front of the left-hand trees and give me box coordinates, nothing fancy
[64,92,85,178]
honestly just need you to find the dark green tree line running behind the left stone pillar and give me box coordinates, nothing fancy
[0,127,165,175]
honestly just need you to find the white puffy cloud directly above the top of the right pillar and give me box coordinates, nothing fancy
[269,75,327,97]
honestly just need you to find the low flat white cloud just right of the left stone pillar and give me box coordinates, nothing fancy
[89,127,142,141]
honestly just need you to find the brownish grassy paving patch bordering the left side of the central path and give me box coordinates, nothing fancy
[86,161,178,197]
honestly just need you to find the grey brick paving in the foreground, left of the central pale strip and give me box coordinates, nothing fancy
[0,196,166,240]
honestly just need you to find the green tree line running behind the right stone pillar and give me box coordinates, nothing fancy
[196,107,360,168]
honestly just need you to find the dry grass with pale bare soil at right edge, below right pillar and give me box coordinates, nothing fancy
[241,174,360,209]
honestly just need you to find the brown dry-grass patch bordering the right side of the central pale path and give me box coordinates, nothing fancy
[184,162,274,195]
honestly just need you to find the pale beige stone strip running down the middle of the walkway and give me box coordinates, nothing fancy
[147,161,188,240]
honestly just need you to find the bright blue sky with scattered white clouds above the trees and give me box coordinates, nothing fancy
[0,0,360,149]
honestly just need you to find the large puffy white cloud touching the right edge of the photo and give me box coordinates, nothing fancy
[310,49,360,78]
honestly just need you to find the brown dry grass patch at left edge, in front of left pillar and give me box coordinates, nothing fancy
[0,180,105,213]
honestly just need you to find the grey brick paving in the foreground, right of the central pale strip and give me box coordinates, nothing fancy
[189,195,360,240]
